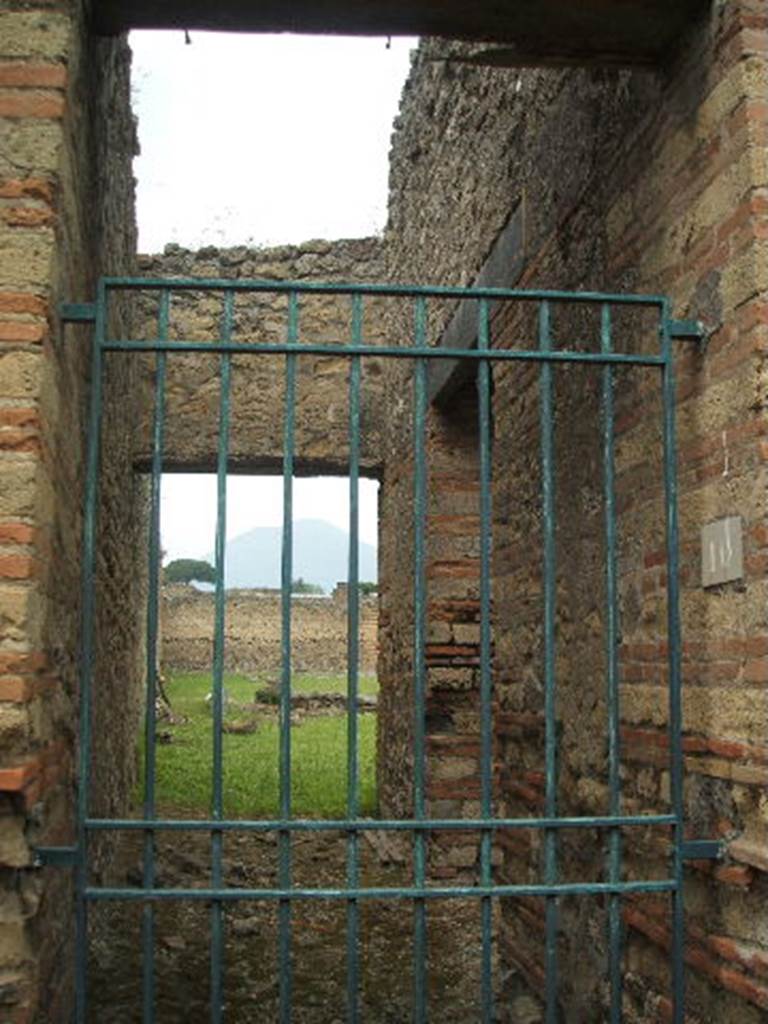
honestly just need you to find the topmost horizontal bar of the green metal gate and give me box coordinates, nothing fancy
[103,278,666,306]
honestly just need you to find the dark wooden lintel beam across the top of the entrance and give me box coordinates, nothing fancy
[91,0,710,66]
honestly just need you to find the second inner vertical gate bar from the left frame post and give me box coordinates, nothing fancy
[211,292,234,1024]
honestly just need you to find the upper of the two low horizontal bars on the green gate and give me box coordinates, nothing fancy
[85,814,677,831]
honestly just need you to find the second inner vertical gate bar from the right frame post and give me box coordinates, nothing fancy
[539,300,558,1024]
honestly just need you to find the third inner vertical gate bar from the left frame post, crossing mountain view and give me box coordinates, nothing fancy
[278,292,299,1024]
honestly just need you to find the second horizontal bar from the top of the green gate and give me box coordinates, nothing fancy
[101,340,664,367]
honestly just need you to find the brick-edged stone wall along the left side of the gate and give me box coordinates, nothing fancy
[0,2,141,1022]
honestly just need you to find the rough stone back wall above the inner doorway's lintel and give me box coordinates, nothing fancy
[136,239,391,473]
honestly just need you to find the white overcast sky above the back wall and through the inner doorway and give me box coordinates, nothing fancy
[131,32,417,559]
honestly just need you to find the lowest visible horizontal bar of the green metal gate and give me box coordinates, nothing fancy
[85,879,677,902]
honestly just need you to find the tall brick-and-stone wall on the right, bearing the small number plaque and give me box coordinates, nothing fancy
[380,0,768,1024]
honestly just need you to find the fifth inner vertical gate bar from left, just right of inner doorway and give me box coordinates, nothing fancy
[414,297,427,1024]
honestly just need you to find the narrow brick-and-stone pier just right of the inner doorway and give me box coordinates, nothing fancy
[378,376,480,879]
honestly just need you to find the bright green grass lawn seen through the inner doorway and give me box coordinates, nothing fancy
[143,673,378,818]
